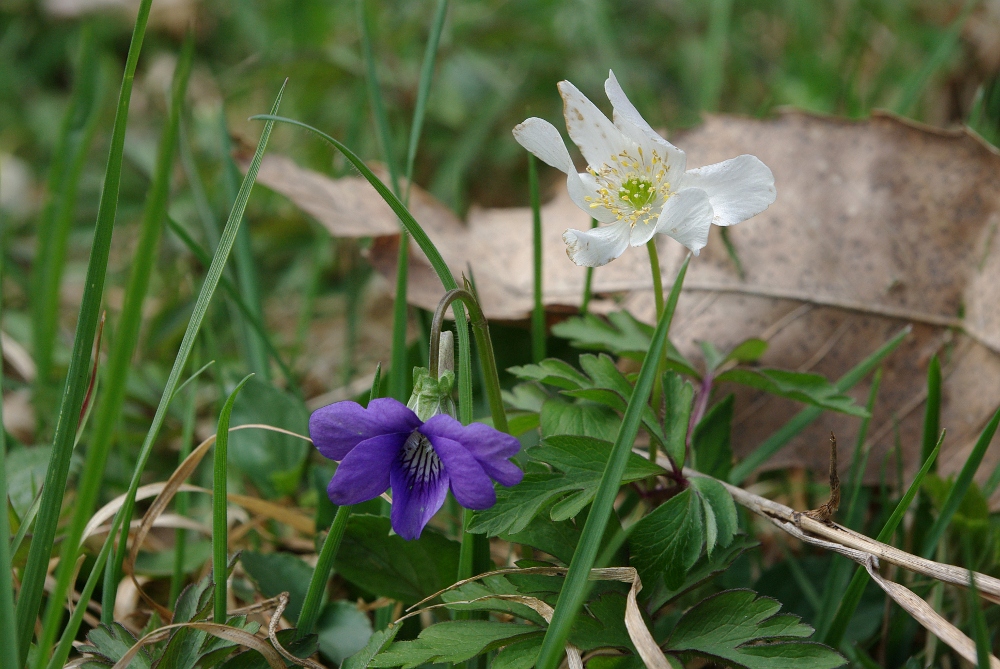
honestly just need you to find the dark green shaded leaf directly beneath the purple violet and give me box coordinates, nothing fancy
[334,515,459,604]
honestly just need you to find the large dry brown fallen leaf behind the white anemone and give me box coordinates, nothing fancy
[252,112,1000,482]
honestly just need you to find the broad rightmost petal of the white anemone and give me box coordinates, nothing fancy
[683,155,776,225]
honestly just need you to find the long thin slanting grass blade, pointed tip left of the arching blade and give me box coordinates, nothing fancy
[105,84,285,614]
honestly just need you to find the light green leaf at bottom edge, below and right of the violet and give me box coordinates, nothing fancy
[369,620,543,669]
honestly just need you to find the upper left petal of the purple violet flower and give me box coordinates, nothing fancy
[309,398,420,460]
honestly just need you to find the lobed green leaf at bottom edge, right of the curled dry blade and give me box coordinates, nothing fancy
[664,590,847,669]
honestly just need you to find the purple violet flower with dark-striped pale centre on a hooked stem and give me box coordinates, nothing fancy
[309,398,524,540]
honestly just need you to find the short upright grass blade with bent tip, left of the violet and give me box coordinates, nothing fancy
[212,374,253,625]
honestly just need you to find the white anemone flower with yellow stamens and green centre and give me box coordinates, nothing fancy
[514,72,775,267]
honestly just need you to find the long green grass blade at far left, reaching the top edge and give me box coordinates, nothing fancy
[16,0,152,665]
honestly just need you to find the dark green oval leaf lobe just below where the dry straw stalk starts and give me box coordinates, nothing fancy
[629,488,705,589]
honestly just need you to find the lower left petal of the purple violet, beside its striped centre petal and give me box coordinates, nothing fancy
[326,433,409,506]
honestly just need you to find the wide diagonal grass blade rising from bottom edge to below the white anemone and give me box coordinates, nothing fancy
[535,256,690,669]
